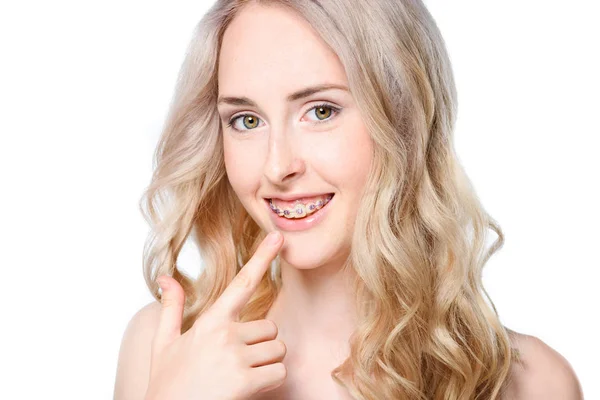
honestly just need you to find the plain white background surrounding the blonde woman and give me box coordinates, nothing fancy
[0,0,600,399]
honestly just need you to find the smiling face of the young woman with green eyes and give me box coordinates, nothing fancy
[218,5,372,268]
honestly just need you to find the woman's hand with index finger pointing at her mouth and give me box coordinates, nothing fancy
[146,231,287,400]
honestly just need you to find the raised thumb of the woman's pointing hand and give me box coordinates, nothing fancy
[154,275,185,349]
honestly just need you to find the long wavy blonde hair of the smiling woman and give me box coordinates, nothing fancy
[140,0,518,400]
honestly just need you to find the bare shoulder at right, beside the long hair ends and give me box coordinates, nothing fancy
[503,329,583,400]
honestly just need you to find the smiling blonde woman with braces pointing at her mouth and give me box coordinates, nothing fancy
[115,0,582,400]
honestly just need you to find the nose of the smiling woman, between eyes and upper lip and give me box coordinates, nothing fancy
[264,131,305,185]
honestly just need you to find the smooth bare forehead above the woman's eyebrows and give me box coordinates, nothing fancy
[218,4,347,95]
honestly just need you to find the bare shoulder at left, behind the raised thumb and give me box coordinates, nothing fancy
[114,301,161,400]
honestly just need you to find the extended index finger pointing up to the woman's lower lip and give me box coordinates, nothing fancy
[213,231,283,319]
